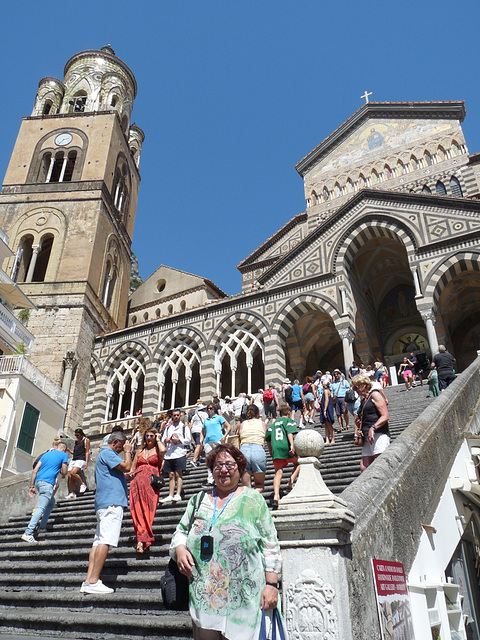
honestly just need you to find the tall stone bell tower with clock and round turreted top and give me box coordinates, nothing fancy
[0,46,144,430]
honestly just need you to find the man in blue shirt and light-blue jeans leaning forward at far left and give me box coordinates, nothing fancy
[22,442,68,543]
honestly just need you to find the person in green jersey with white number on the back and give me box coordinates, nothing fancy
[265,404,300,509]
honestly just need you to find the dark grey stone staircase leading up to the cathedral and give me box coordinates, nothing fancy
[0,386,433,640]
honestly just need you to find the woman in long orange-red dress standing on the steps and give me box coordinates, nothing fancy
[128,427,166,553]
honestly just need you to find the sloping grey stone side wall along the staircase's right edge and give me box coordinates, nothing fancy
[341,358,480,640]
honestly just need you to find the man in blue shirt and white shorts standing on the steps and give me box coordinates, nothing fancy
[80,431,132,594]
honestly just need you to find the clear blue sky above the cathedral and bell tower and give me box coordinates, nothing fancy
[0,0,480,294]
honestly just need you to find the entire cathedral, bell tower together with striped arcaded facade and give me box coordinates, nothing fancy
[0,47,480,430]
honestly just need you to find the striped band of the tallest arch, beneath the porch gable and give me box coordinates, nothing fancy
[332,216,416,274]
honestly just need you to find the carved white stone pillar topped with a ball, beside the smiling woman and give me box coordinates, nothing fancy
[273,429,355,640]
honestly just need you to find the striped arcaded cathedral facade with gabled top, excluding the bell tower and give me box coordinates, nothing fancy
[86,102,480,428]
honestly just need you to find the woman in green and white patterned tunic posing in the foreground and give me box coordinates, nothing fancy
[170,444,281,640]
